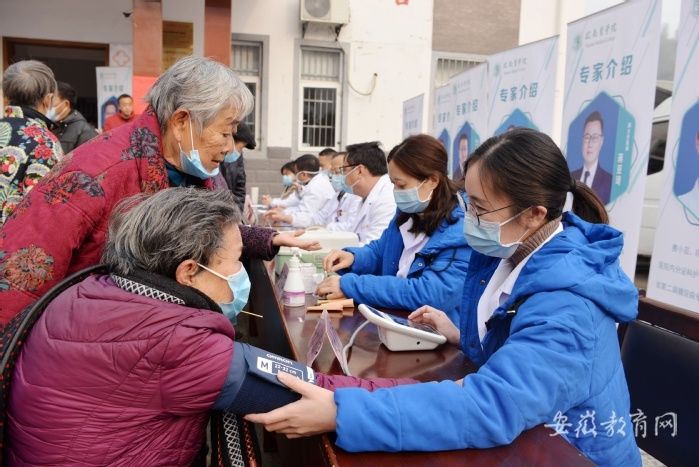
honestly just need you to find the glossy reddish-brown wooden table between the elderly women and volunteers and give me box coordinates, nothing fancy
[243,261,594,467]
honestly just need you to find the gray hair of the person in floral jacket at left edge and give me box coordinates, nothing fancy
[2,60,56,108]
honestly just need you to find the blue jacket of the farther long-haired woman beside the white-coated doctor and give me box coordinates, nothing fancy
[340,196,471,325]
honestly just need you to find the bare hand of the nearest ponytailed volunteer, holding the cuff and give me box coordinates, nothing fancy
[245,372,337,438]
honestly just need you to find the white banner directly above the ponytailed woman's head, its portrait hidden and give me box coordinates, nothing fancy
[488,36,558,136]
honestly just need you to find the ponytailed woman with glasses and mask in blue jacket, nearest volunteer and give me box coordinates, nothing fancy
[249,129,641,466]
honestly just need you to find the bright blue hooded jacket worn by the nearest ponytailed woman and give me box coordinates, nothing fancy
[335,213,641,466]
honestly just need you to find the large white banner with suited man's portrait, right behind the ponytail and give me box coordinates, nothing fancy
[561,0,661,278]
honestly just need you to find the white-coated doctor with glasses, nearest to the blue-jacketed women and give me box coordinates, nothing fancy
[341,141,396,246]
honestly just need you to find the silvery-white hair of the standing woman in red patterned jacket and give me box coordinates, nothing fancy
[146,56,254,132]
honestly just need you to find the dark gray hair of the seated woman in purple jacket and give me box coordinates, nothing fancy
[102,188,240,279]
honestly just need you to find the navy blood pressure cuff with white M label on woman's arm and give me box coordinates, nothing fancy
[213,341,315,415]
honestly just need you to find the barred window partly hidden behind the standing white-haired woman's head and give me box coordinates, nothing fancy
[232,40,262,146]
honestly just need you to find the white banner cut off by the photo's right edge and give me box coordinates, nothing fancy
[648,0,699,312]
